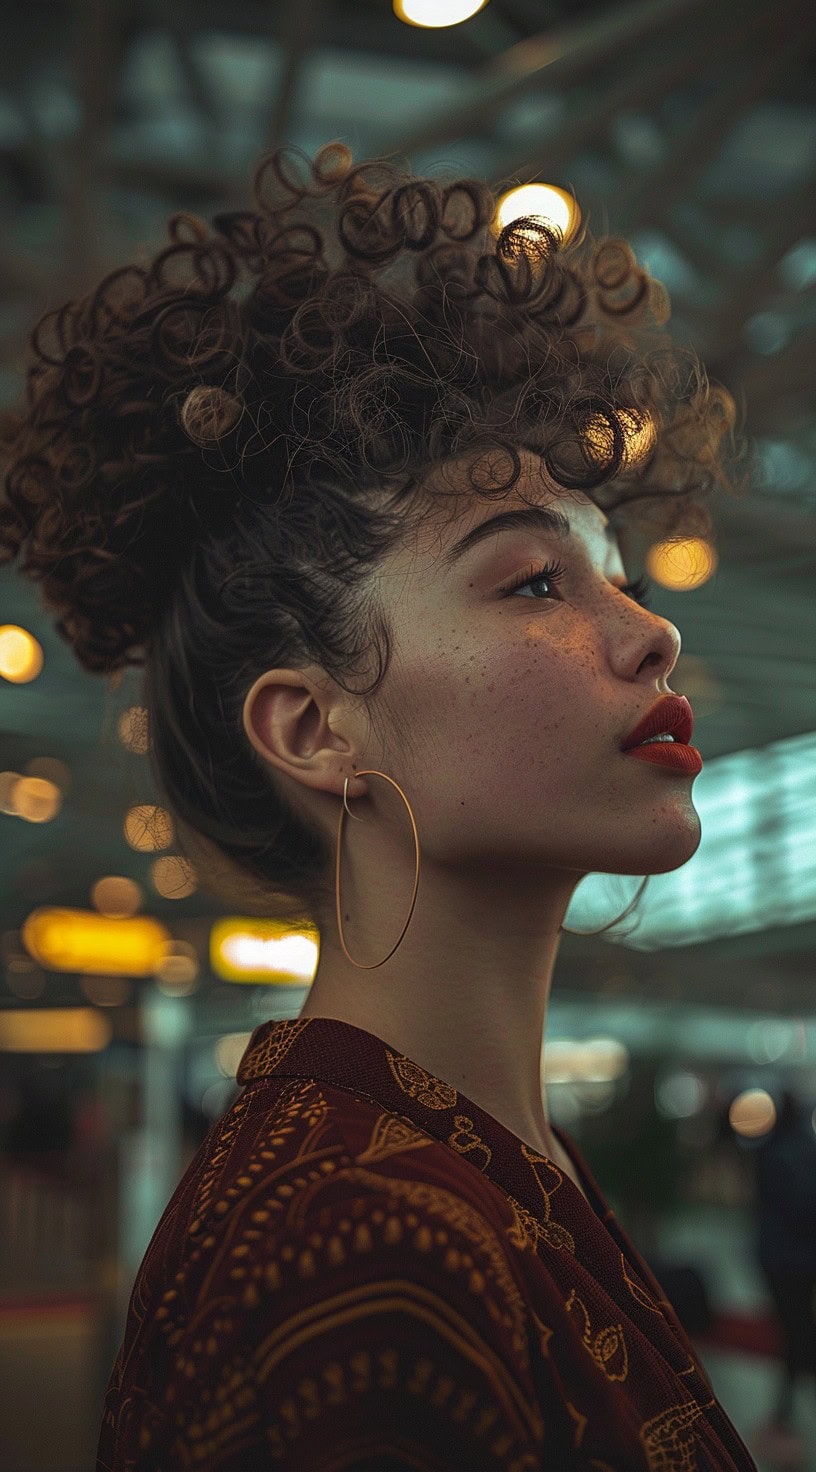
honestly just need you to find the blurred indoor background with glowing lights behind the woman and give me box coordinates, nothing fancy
[0,0,816,1472]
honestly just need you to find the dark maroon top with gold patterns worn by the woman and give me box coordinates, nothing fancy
[96,1017,756,1472]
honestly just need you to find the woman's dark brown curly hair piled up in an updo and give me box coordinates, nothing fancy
[0,144,744,919]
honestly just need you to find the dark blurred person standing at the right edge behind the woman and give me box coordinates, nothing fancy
[754,1089,816,1460]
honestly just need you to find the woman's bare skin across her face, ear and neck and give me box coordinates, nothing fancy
[243,452,701,1179]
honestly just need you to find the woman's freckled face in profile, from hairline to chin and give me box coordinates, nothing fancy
[371,453,700,879]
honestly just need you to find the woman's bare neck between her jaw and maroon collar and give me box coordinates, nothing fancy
[300,864,582,1156]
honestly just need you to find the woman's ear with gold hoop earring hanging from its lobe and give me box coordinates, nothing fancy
[242,668,368,798]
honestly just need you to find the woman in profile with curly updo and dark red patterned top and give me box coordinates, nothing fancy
[3,144,754,1472]
